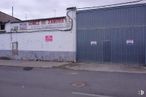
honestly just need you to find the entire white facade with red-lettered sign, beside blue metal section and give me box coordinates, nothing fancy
[0,8,76,62]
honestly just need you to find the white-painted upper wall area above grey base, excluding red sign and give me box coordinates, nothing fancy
[0,7,76,52]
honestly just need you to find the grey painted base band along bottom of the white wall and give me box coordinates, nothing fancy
[0,50,76,62]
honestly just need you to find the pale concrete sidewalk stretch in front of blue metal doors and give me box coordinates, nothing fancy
[65,63,146,73]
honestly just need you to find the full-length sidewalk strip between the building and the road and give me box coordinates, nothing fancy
[0,60,146,73]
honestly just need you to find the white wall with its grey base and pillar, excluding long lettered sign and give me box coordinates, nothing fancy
[0,7,76,61]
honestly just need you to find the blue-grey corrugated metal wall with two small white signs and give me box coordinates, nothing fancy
[77,4,146,64]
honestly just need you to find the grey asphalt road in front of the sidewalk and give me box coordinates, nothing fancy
[0,67,146,97]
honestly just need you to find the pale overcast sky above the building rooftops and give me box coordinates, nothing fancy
[0,0,145,20]
